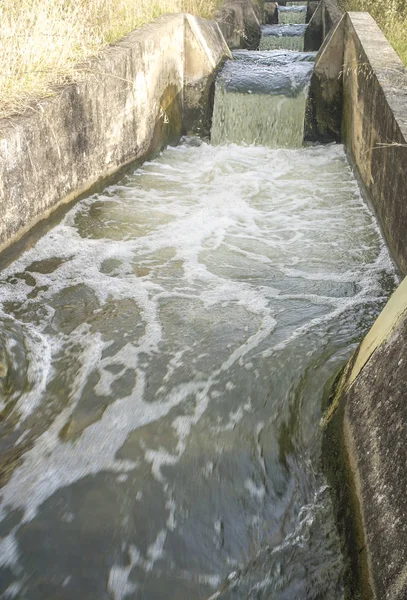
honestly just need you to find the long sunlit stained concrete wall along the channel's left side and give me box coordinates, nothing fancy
[0,14,229,250]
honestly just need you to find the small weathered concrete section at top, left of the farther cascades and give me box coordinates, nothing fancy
[215,0,262,50]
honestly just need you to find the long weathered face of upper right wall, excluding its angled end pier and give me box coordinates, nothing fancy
[343,13,407,274]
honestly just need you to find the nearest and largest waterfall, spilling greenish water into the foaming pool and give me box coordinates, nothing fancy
[211,50,315,148]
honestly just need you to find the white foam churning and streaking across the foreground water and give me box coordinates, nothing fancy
[1,144,395,572]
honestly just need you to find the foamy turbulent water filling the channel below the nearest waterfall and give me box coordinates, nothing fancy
[0,140,394,600]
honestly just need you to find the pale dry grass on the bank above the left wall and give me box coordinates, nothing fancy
[0,0,223,117]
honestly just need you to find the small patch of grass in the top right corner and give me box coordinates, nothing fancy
[339,0,407,65]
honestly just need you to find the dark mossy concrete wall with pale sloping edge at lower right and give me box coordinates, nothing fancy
[324,279,407,600]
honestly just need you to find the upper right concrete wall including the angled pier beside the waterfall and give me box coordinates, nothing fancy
[306,13,407,274]
